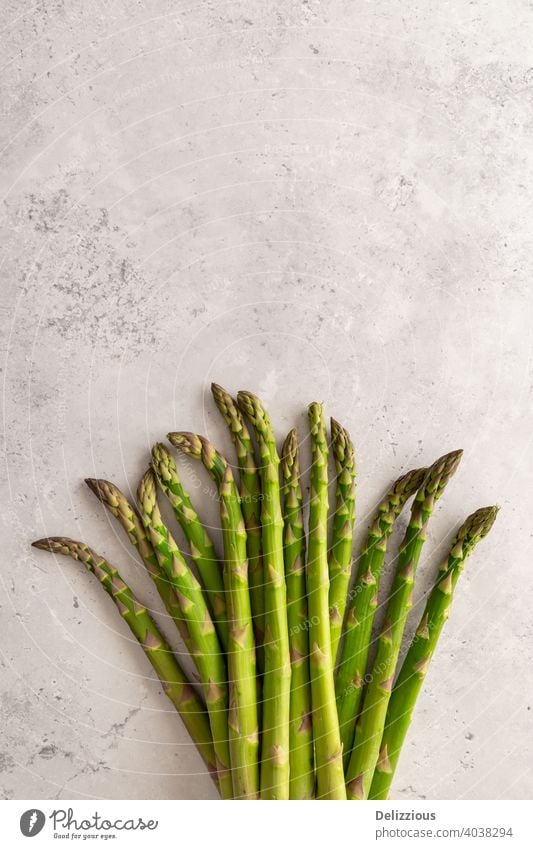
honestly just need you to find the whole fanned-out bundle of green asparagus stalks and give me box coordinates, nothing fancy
[33,384,497,800]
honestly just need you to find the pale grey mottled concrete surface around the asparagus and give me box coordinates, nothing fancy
[0,0,533,799]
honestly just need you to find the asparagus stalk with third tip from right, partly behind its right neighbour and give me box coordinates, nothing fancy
[335,469,427,769]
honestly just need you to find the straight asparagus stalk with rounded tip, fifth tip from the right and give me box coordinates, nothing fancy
[280,429,315,799]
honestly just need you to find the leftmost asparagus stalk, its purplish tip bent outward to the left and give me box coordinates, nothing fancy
[32,537,217,776]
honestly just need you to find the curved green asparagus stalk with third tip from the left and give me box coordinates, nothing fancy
[138,469,233,799]
